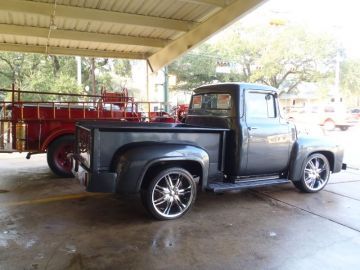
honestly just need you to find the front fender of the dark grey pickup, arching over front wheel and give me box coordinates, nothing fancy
[288,136,344,181]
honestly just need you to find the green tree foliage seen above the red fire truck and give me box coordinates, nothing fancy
[0,52,131,101]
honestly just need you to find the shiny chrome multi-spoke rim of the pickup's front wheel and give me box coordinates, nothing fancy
[304,157,330,191]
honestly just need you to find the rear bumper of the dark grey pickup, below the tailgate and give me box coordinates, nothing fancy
[70,154,117,193]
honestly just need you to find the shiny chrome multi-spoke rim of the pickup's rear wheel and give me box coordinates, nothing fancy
[151,173,195,218]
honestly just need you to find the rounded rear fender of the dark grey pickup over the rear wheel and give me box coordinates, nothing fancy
[113,143,209,193]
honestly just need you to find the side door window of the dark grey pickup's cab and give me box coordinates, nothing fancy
[245,92,276,118]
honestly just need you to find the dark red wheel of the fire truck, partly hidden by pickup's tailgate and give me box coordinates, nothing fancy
[47,135,75,177]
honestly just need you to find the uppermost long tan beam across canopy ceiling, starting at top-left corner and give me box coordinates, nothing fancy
[0,0,197,32]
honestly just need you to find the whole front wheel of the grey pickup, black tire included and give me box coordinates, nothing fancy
[293,154,330,193]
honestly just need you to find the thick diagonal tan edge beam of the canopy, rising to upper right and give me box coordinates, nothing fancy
[148,0,267,72]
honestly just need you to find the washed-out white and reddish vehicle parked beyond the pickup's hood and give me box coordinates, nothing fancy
[286,104,355,131]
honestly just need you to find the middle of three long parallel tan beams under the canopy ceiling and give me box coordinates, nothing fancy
[0,24,168,48]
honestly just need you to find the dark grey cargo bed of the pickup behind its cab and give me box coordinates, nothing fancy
[77,121,228,177]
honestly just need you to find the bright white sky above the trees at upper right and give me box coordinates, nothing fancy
[211,0,360,58]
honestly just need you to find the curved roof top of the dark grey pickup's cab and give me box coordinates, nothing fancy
[194,82,279,93]
